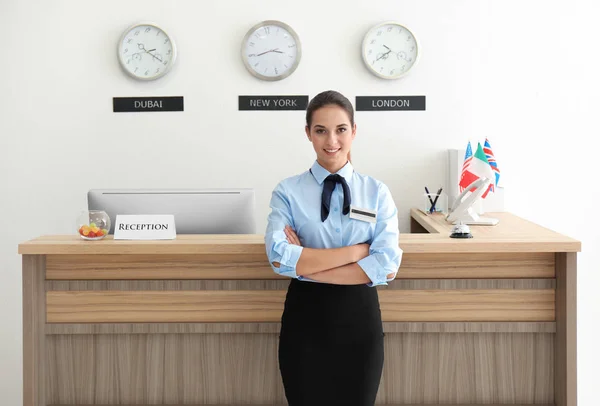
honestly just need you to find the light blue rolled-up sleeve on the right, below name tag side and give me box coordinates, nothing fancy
[357,183,402,287]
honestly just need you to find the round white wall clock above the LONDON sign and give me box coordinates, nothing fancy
[362,22,419,79]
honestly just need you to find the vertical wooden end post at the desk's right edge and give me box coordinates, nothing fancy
[555,253,577,406]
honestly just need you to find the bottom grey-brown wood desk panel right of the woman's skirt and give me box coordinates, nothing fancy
[378,334,553,404]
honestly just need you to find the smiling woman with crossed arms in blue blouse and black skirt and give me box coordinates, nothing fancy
[265,91,402,406]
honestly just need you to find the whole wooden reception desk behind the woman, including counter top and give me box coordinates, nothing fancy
[19,210,581,406]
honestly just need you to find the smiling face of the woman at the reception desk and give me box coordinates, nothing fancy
[306,104,356,173]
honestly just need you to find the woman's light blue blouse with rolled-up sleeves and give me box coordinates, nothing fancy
[265,161,402,286]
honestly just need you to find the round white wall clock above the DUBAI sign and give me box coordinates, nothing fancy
[118,24,176,80]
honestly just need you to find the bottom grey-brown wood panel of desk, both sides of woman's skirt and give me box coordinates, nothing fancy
[47,333,554,405]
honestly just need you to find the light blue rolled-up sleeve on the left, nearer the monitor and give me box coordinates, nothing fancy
[265,183,303,279]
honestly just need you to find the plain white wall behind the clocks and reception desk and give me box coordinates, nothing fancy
[0,0,600,406]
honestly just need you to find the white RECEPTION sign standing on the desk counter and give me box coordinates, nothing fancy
[114,214,176,240]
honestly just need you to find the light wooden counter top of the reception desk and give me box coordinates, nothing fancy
[19,209,581,255]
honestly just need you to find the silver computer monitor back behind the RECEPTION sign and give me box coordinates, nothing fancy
[87,189,256,234]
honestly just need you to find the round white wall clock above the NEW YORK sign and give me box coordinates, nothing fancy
[242,21,302,80]
